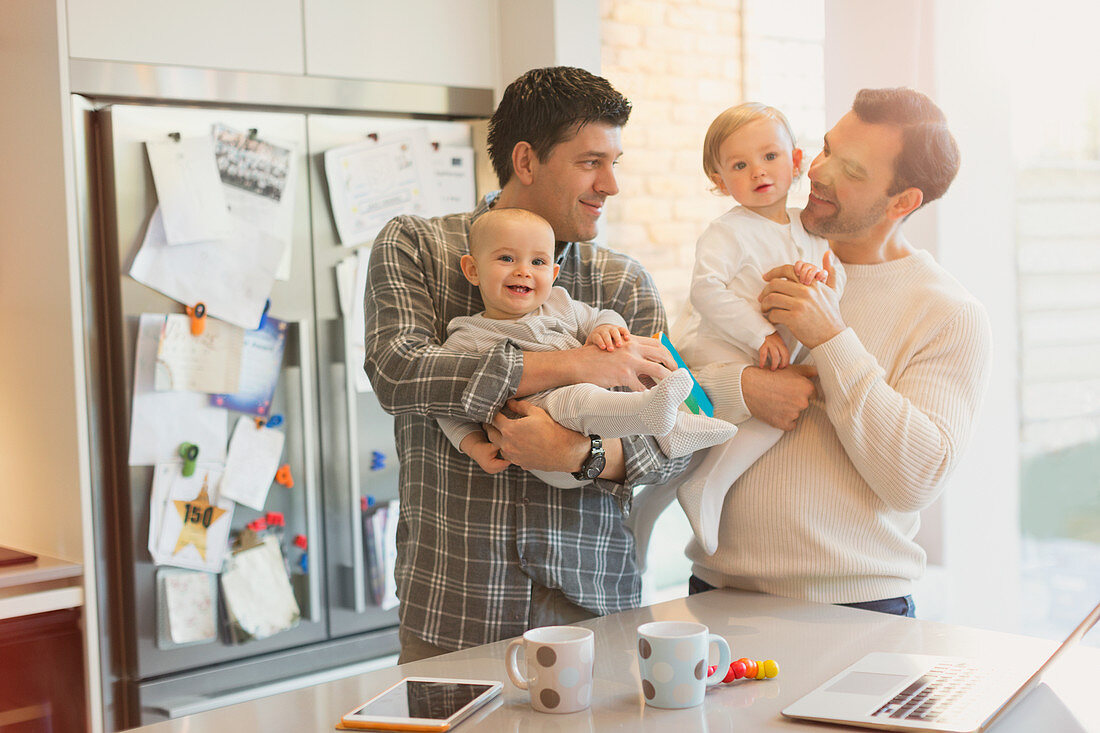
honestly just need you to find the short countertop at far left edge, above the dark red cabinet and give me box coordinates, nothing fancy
[0,545,84,620]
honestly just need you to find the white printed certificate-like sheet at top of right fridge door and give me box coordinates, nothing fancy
[325,128,442,247]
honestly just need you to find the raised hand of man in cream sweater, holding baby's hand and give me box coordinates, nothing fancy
[759,252,846,349]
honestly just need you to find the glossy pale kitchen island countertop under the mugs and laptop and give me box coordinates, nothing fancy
[124,590,1100,733]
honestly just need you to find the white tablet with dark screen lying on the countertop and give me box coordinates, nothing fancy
[340,677,502,731]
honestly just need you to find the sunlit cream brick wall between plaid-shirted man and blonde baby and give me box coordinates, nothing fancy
[601,0,741,317]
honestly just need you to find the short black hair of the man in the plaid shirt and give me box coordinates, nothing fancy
[488,66,630,187]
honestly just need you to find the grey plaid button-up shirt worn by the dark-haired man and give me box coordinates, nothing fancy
[365,198,688,649]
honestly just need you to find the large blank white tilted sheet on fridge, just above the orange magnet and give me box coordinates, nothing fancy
[130,207,284,329]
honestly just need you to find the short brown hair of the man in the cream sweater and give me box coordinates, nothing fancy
[851,87,959,206]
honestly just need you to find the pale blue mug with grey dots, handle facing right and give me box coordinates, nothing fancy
[638,621,729,708]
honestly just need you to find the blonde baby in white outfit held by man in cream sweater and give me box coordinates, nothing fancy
[670,102,845,554]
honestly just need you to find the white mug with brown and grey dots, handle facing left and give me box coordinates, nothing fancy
[504,626,595,713]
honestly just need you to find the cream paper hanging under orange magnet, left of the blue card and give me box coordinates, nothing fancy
[153,314,244,394]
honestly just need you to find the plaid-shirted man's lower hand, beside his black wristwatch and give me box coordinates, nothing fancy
[485,400,592,472]
